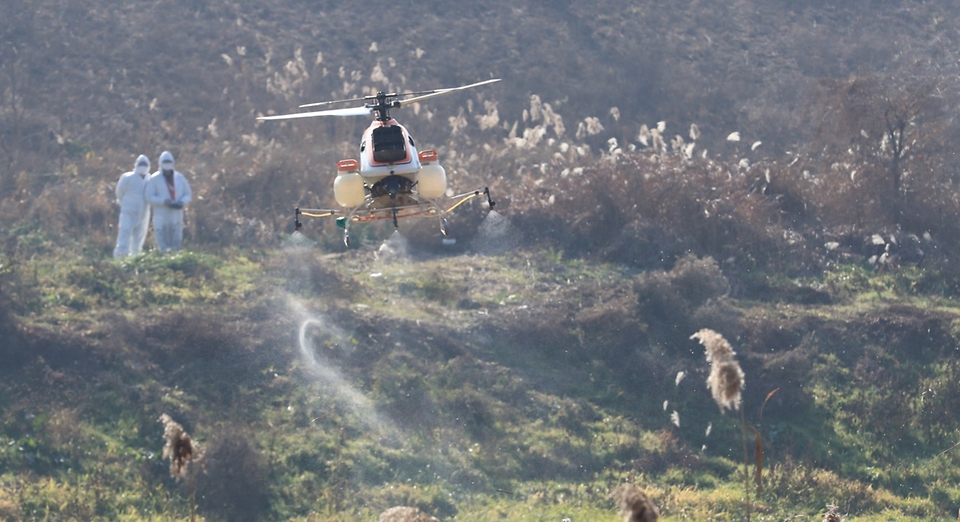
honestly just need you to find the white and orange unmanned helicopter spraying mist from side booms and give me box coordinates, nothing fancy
[257,78,500,246]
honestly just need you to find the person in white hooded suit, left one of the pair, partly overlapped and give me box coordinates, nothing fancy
[113,154,150,258]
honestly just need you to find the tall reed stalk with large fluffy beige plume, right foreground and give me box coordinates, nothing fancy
[690,328,752,522]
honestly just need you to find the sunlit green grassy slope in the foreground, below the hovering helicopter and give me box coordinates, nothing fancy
[0,239,960,520]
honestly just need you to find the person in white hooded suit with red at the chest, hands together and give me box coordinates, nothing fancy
[144,151,191,252]
